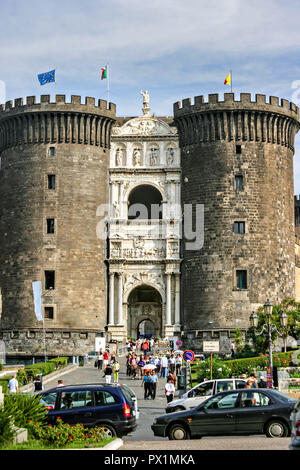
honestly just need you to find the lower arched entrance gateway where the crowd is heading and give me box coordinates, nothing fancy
[127,285,162,338]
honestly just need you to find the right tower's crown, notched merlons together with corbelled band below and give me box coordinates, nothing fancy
[174,93,300,150]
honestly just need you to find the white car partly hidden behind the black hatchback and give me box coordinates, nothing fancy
[165,379,247,413]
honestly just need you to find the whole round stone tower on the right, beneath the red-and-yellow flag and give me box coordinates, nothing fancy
[174,93,299,337]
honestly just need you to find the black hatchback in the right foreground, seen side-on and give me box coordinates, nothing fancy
[151,388,296,440]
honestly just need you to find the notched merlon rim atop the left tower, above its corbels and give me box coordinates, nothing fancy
[0,95,116,118]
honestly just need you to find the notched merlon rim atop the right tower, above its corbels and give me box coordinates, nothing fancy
[174,93,299,119]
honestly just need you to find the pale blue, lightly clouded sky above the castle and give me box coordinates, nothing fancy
[0,0,300,194]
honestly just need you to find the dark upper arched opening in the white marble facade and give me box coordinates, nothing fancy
[128,185,162,220]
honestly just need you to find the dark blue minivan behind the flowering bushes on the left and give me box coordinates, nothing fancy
[38,384,137,437]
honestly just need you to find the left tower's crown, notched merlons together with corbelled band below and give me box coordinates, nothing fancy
[0,95,116,150]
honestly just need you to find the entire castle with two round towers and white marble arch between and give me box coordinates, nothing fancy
[0,92,300,357]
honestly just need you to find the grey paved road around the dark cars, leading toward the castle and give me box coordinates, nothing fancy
[46,358,290,451]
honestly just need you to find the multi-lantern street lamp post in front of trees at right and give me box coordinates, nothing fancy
[250,299,288,386]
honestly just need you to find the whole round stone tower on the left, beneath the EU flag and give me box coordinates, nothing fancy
[0,95,115,355]
